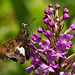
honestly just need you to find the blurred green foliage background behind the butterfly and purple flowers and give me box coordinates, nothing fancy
[0,0,75,75]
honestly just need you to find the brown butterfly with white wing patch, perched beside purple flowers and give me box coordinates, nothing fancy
[0,24,30,64]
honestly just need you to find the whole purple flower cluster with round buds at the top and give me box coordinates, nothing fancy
[26,4,75,75]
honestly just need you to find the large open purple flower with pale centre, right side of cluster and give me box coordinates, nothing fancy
[56,34,72,52]
